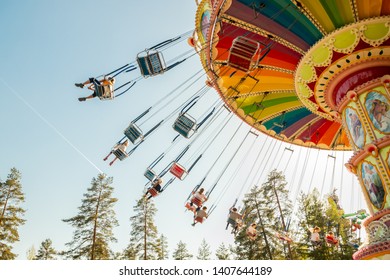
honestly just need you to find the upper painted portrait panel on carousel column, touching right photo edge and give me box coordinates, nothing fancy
[365,91,390,134]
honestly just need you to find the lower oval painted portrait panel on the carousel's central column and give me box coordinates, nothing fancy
[362,162,385,209]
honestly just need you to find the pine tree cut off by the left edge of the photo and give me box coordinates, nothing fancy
[0,168,25,260]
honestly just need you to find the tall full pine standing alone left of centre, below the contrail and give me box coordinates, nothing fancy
[63,174,118,260]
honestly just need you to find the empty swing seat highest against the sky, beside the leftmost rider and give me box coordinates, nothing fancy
[137,50,166,78]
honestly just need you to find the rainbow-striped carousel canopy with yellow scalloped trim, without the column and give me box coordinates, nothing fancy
[193,0,390,150]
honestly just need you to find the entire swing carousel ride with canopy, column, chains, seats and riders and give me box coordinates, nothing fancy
[76,0,390,259]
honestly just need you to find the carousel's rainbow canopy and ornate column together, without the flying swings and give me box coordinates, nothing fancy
[189,0,390,259]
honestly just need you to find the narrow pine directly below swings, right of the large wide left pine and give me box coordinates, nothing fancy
[125,197,157,260]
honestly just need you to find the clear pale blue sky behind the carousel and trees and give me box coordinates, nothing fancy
[0,0,364,259]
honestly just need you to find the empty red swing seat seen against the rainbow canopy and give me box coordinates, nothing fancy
[228,36,260,72]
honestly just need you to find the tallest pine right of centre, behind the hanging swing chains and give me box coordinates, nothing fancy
[234,170,292,260]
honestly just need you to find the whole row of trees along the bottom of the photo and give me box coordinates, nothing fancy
[0,168,359,260]
